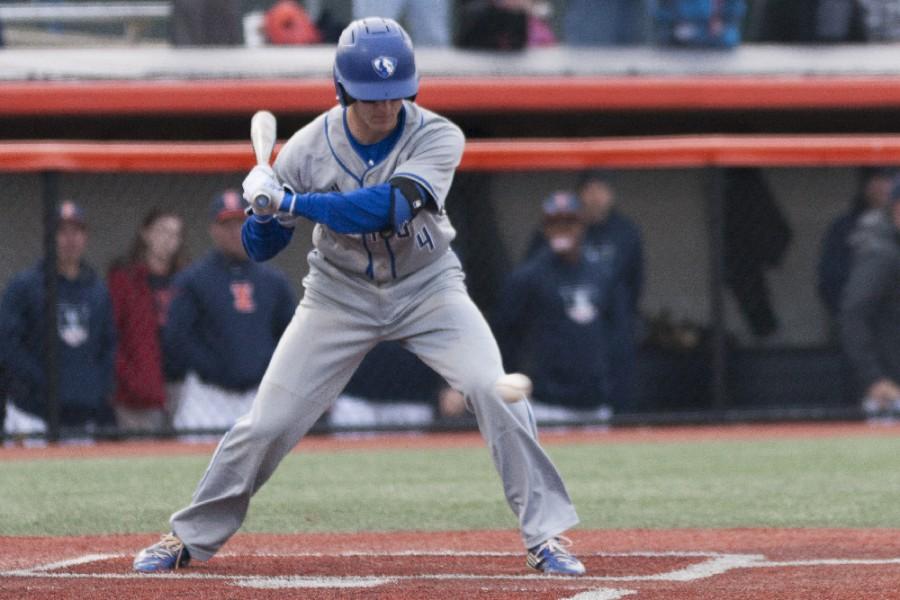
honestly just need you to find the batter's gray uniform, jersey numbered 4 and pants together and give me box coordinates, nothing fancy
[171,102,578,560]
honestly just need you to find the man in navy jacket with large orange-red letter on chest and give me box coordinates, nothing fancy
[163,189,296,431]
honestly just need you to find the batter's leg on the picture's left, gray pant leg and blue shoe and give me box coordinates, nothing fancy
[134,288,375,572]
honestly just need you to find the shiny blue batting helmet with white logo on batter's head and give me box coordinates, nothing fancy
[333,17,419,106]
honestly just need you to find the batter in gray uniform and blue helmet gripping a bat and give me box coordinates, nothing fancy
[134,18,584,575]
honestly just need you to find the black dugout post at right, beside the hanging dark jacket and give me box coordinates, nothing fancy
[706,166,728,411]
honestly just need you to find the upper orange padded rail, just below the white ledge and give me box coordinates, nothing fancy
[0,76,900,116]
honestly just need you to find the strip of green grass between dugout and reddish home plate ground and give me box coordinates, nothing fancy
[0,437,900,535]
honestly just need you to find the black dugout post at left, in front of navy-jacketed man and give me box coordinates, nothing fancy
[41,171,60,442]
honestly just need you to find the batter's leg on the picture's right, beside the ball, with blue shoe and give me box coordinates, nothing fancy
[391,280,583,574]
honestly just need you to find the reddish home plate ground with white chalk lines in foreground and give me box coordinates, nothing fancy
[0,530,900,600]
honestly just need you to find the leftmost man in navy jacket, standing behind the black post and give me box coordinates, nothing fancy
[0,200,116,435]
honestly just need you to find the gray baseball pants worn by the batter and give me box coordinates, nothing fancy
[170,250,578,560]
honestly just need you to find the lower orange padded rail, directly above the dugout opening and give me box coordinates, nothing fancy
[0,135,900,173]
